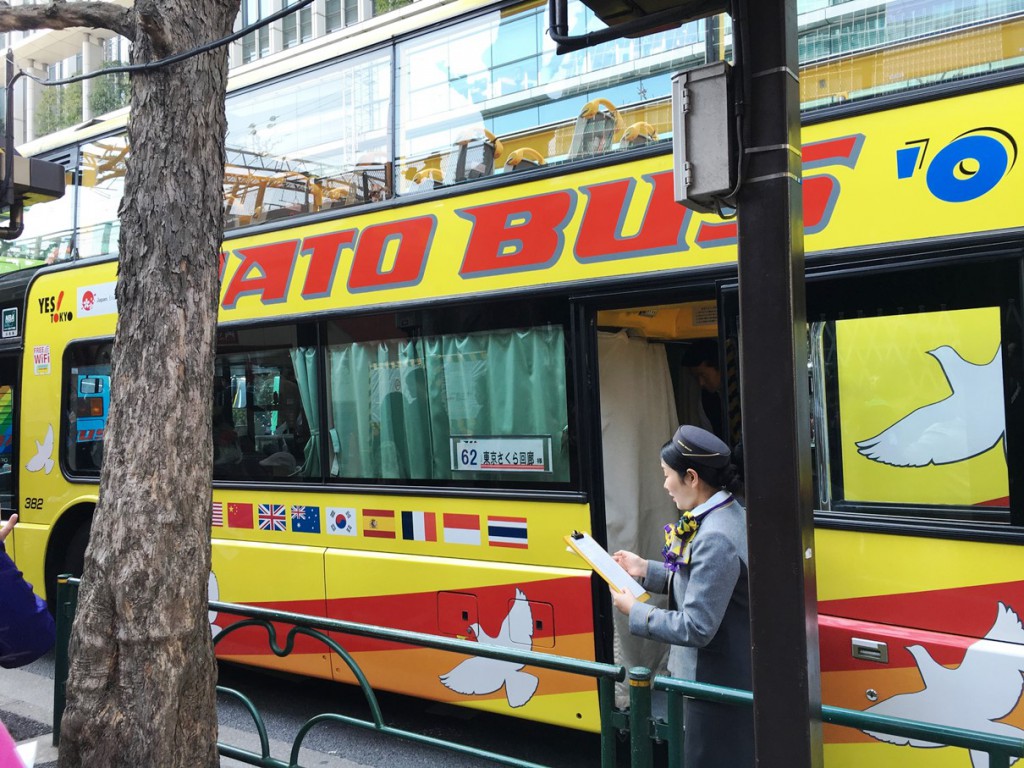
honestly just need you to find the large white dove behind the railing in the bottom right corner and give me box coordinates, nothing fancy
[865,603,1024,768]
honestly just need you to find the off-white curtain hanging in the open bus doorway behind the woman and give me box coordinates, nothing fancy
[597,332,678,698]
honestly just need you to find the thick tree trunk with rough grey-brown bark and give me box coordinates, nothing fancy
[0,0,239,768]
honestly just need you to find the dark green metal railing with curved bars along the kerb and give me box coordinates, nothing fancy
[53,577,1024,768]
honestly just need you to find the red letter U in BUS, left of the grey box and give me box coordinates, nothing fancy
[574,171,690,262]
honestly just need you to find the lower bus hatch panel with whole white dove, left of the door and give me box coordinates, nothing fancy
[327,551,598,730]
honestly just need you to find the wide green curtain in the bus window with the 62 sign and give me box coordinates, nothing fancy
[329,327,568,481]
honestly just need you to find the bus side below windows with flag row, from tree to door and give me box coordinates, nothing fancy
[204,489,598,729]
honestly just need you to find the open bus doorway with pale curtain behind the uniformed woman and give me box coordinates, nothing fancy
[597,300,733,698]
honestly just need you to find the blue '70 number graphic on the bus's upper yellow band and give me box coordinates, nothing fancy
[896,126,1017,203]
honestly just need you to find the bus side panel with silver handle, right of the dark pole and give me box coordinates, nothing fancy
[815,529,1024,768]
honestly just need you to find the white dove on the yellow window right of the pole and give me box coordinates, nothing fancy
[857,345,1006,467]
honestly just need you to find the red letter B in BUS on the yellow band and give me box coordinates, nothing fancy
[456,190,575,278]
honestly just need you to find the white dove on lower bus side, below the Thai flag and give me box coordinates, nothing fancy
[440,589,539,707]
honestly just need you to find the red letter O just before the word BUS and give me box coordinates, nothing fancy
[348,216,437,292]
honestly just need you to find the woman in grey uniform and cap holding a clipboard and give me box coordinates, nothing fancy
[612,426,754,768]
